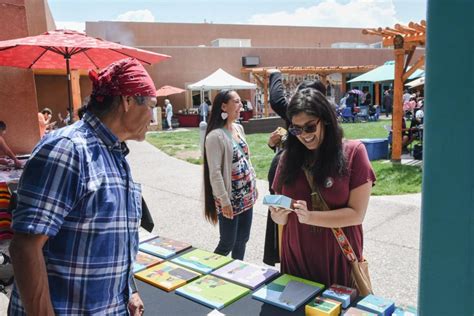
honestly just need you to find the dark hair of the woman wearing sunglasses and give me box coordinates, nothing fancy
[279,89,346,189]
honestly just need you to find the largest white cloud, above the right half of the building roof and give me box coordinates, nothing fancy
[249,0,398,27]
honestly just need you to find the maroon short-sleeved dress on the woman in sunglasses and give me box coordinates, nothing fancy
[273,140,375,286]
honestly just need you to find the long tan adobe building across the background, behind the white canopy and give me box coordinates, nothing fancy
[86,21,404,111]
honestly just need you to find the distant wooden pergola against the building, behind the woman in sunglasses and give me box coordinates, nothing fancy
[241,65,377,117]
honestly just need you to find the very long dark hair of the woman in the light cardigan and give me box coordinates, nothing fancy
[203,90,234,224]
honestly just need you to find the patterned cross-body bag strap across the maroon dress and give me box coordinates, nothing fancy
[303,168,357,262]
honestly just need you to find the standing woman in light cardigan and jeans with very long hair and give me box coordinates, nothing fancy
[203,90,257,260]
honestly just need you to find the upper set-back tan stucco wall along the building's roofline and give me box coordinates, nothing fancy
[86,21,379,47]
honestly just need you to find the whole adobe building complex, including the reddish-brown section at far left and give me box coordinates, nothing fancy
[0,0,422,153]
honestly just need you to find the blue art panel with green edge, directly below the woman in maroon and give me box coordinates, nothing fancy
[252,274,324,311]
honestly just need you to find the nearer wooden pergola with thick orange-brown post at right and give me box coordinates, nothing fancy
[362,20,426,162]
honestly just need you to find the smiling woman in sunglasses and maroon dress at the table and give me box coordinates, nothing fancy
[271,89,375,287]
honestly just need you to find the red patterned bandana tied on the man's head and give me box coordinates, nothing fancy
[89,58,156,101]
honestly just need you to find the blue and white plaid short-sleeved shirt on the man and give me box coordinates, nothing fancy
[9,113,141,315]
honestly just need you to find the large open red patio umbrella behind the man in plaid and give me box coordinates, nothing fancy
[0,30,170,118]
